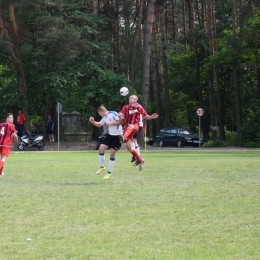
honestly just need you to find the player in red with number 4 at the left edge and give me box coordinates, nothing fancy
[0,113,18,178]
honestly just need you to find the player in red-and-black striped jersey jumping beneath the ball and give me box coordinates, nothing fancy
[108,95,158,171]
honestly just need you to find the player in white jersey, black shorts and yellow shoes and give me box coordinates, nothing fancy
[89,106,123,180]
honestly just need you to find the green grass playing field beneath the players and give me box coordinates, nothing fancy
[0,151,260,260]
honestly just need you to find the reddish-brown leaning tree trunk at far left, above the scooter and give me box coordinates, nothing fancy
[9,3,30,130]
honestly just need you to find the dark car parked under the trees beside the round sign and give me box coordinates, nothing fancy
[155,127,204,147]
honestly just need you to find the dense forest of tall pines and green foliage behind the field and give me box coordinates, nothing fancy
[0,0,260,147]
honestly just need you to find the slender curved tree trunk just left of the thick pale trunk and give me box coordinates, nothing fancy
[130,0,144,88]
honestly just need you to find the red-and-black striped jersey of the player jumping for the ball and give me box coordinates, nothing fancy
[119,104,147,126]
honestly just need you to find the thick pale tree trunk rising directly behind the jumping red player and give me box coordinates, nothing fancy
[141,0,156,110]
